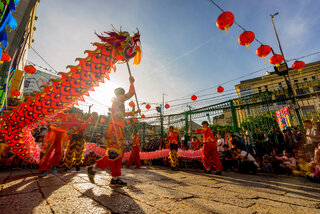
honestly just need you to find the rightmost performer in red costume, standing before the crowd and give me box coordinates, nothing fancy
[194,121,222,175]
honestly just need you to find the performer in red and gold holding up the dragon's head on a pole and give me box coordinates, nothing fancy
[87,77,140,186]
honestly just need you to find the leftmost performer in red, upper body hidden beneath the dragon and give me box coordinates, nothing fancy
[39,124,68,177]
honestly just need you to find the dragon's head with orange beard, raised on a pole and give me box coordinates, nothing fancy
[96,31,141,65]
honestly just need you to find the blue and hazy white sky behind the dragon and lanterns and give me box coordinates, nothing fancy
[28,0,320,116]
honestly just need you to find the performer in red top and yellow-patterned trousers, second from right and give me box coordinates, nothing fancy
[166,126,179,171]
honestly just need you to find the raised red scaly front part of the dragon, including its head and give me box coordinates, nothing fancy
[0,32,141,163]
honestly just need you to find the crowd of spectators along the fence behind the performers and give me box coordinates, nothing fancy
[0,120,320,182]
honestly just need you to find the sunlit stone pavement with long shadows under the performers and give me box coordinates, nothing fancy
[0,166,320,214]
